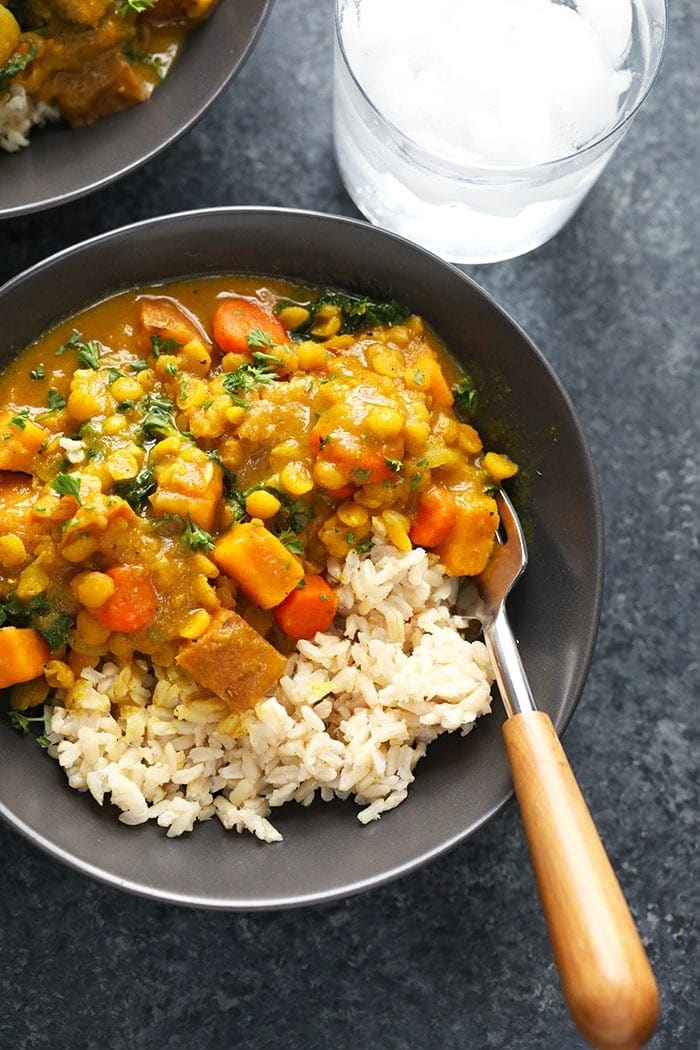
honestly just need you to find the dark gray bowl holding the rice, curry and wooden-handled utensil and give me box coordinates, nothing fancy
[0,208,602,908]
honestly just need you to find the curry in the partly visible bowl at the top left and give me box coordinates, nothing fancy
[0,0,218,126]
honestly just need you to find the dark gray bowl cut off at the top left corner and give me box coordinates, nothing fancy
[0,0,272,218]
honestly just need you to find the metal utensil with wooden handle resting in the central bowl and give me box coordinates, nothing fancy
[476,492,659,1050]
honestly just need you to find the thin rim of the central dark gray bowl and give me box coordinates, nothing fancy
[0,205,604,911]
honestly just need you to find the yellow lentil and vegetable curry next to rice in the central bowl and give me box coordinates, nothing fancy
[0,276,516,711]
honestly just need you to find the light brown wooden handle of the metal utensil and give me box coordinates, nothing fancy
[503,711,659,1050]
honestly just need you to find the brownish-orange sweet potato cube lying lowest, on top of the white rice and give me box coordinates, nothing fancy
[175,609,287,711]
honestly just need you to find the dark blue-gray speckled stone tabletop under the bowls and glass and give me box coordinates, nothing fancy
[0,0,700,1050]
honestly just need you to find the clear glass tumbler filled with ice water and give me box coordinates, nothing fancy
[334,0,666,263]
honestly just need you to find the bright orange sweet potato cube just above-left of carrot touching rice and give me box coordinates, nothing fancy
[212,519,303,609]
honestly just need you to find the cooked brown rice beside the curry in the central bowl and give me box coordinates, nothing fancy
[46,527,493,842]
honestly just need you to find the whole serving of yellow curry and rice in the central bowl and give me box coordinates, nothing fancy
[0,276,516,841]
